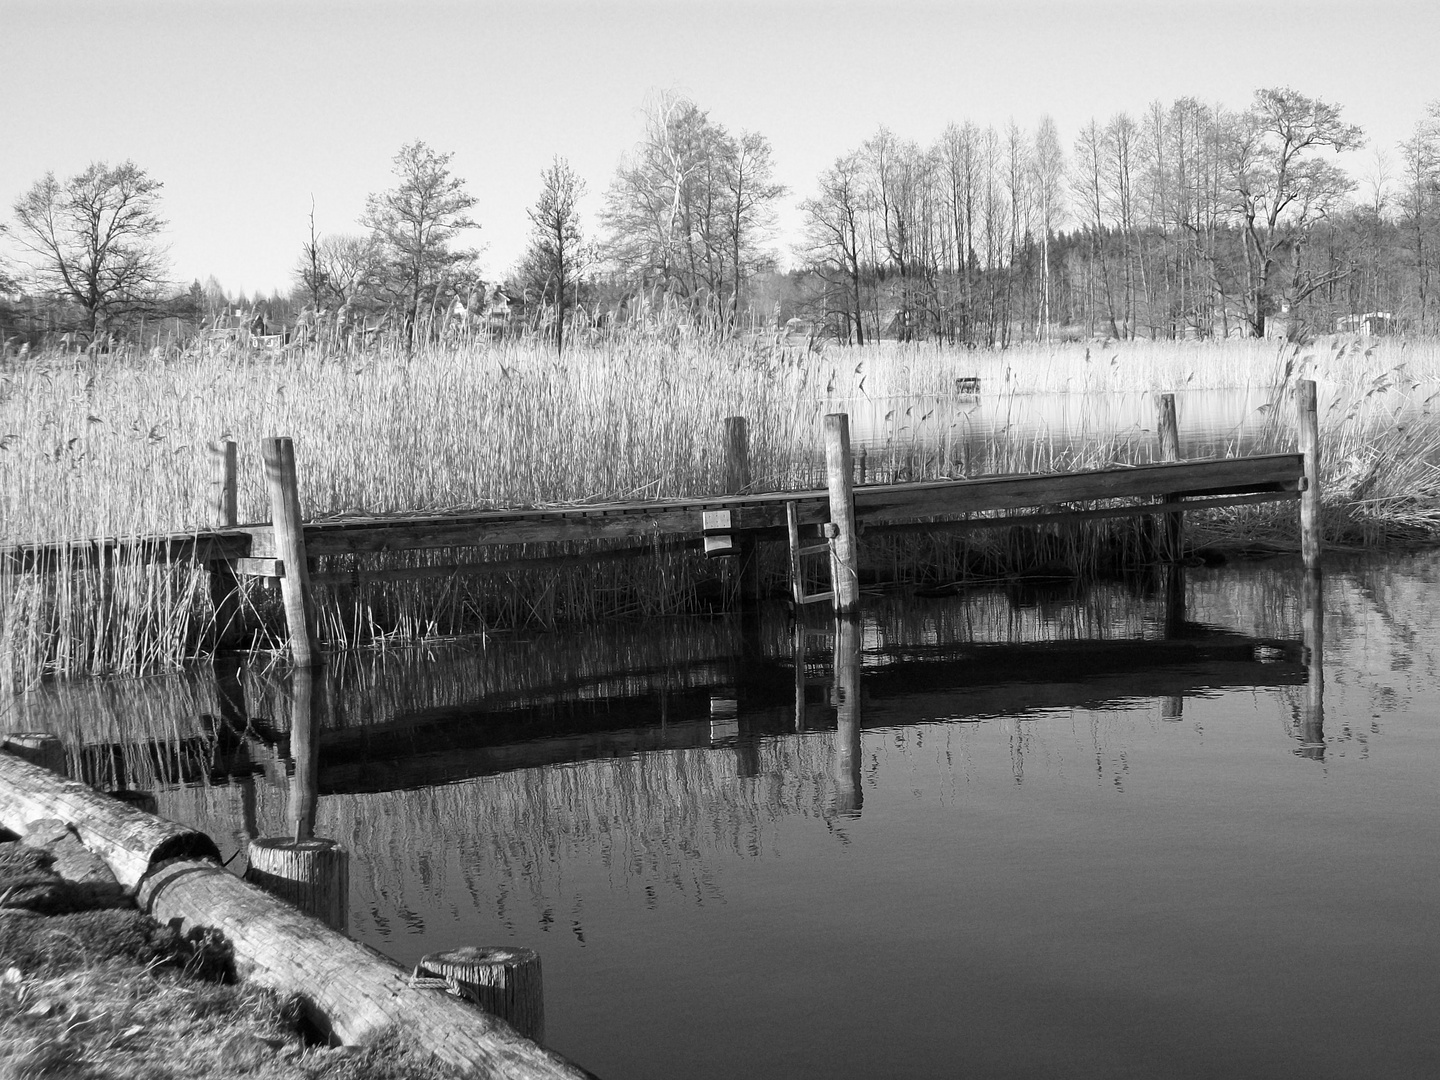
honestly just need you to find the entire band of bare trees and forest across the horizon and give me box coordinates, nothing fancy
[8,88,1440,346]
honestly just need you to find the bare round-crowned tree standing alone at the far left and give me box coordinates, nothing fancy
[14,161,166,337]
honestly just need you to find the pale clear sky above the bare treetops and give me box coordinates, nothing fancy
[0,0,1440,294]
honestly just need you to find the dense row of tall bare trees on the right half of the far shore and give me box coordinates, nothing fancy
[802,89,1440,344]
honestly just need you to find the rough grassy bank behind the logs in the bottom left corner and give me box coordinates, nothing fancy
[0,842,454,1080]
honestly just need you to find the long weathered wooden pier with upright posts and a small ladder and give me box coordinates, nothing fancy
[0,382,1320,665]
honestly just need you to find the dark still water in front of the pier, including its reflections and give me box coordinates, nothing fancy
[9,554,1440,1079]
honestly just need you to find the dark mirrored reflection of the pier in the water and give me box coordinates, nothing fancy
[12,573,1323,806]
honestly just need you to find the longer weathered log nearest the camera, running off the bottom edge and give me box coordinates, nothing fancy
[140,860,590,1080]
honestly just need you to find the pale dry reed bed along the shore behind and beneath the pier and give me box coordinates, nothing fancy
[0,337,1440,688]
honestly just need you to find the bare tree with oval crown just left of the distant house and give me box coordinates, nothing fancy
[363,140,477,348]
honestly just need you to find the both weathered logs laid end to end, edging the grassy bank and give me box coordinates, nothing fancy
[0,752,593,1080]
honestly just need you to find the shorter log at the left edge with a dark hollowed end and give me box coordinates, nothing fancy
[0,753,220,888]
